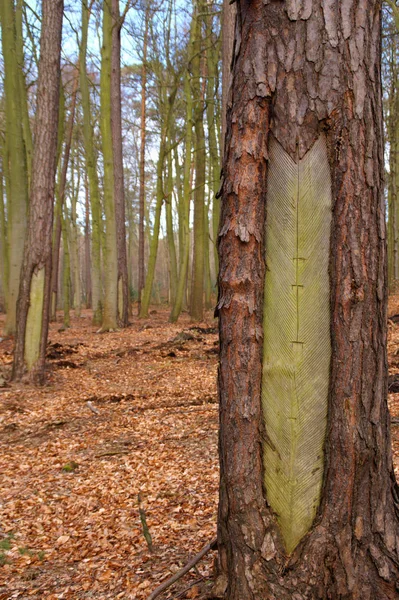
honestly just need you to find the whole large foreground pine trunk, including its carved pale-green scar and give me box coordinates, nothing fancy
[218,0,399,600]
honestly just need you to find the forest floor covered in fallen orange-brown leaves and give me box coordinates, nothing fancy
[0,296,399,600]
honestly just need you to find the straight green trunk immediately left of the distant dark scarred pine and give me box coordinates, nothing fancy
[100,1,118,332]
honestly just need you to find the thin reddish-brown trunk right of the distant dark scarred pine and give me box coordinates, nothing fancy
[137,4,149,314]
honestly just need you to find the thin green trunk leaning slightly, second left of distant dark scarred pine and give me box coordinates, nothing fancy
[79,0,102,325]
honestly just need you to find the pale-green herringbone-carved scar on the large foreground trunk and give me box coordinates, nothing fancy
[262,135,332,553]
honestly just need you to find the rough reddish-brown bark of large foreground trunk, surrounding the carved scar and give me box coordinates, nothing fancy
[218,0,399,600]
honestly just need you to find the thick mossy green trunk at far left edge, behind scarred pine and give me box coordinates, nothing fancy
[0,0,28,334]
